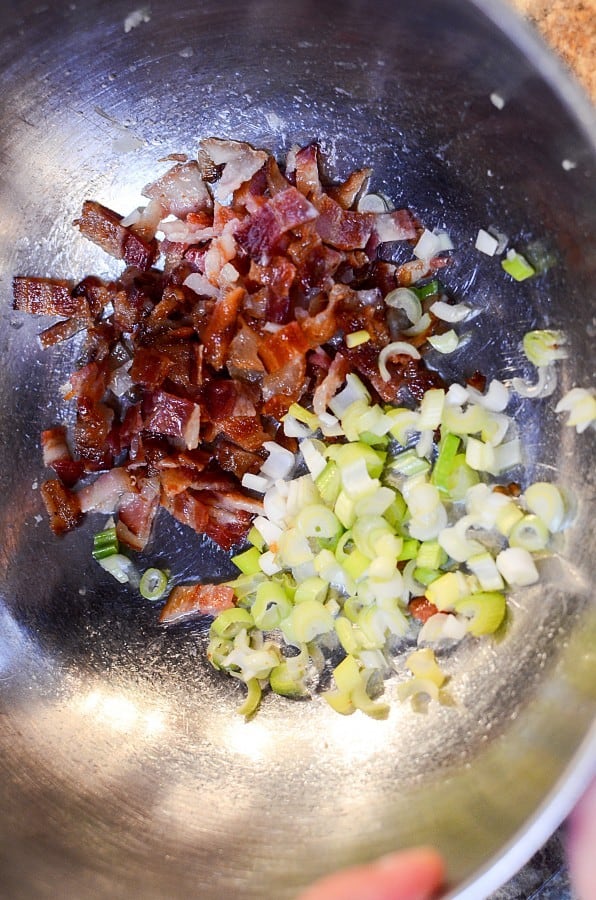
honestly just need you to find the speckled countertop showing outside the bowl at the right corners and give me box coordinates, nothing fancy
[489,8,596,900]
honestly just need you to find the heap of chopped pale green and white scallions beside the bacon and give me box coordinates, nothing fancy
[203,370,567,718]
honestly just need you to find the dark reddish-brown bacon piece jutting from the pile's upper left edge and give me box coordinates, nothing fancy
[75,200,158,269]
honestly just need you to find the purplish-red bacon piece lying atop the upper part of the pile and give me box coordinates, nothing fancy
[236,187,318,263]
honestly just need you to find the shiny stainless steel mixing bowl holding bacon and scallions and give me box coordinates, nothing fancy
[0,0,596,900]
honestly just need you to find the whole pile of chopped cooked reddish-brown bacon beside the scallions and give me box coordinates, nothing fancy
[14,138,449,549]
